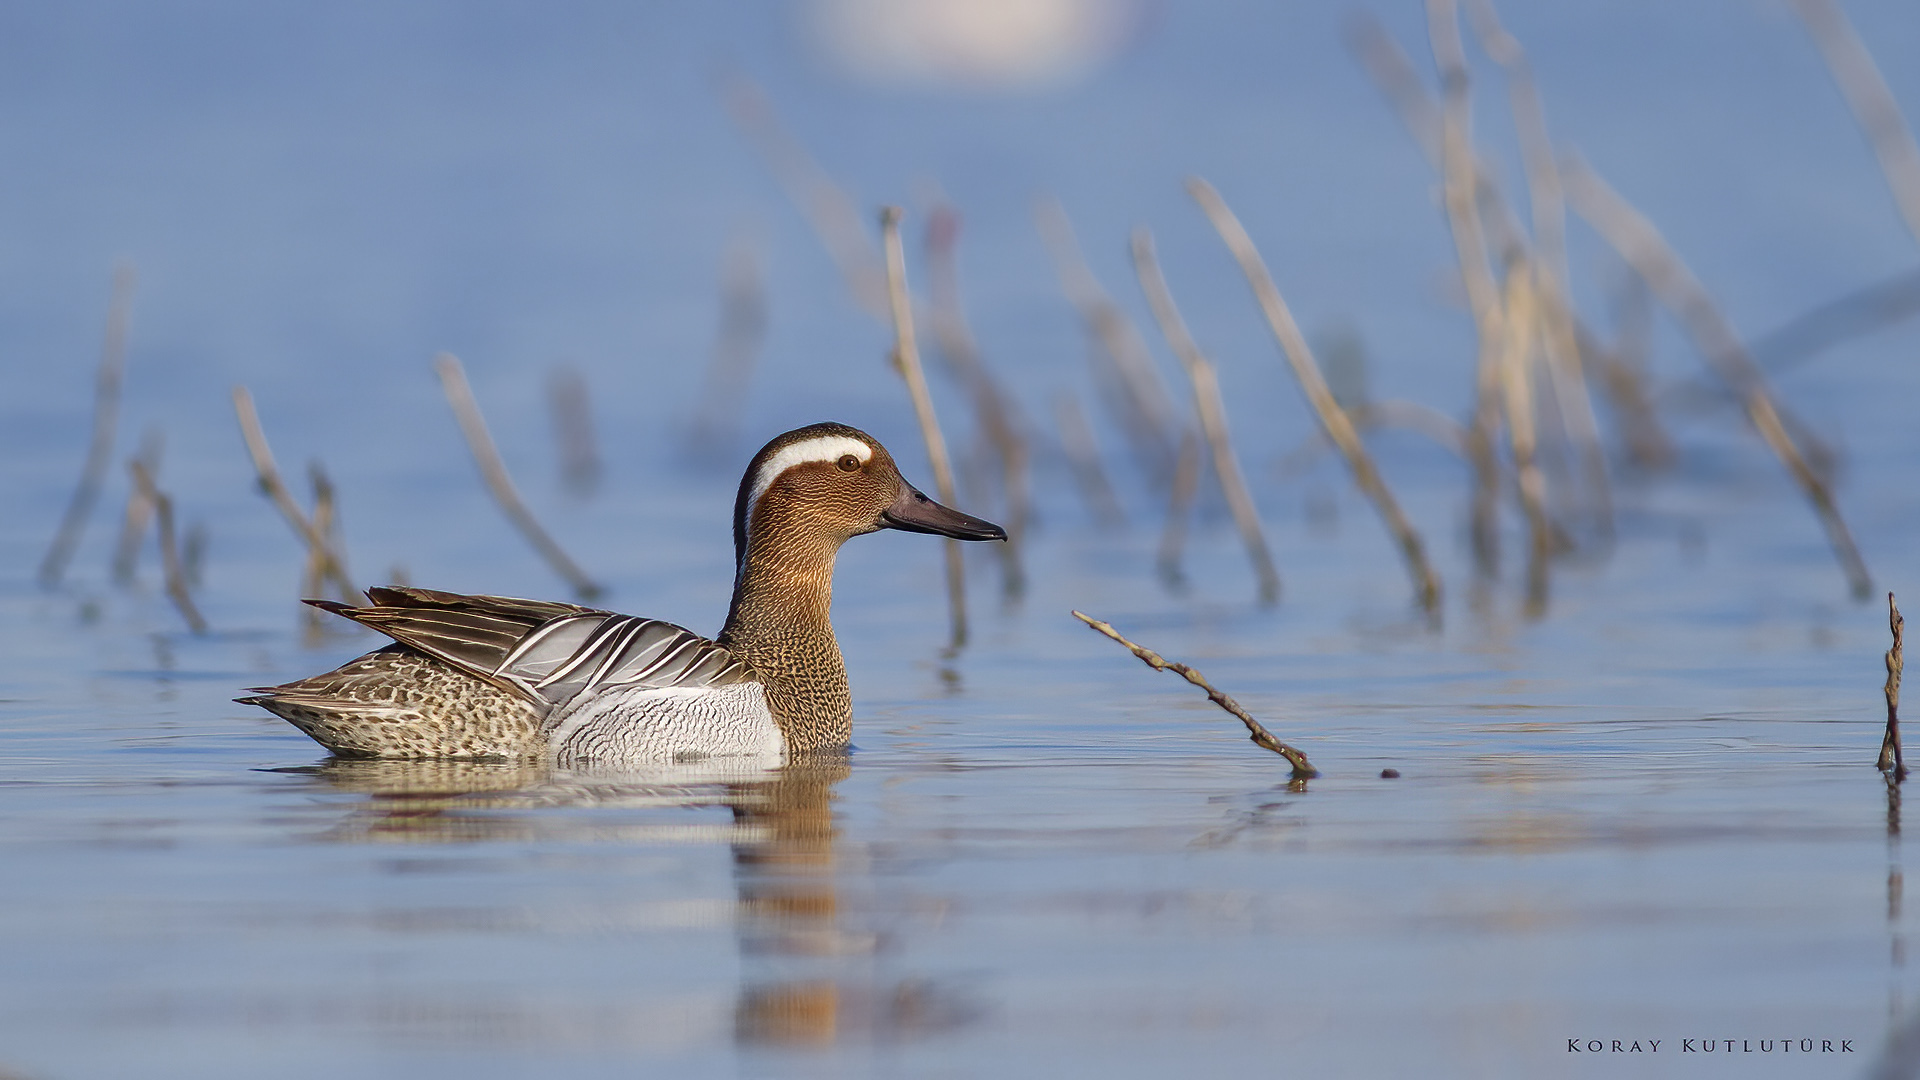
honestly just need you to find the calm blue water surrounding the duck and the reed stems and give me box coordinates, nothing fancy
[0,2,1920,1080]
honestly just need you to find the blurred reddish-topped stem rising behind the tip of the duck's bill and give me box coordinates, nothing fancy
[927,206,1031,600]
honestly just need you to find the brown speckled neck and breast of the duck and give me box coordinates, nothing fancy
[718,500,852,753]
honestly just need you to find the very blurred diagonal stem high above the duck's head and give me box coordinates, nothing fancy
[724,77,889,315]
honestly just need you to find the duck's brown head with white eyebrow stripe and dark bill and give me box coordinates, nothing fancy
[733,423,1006,567]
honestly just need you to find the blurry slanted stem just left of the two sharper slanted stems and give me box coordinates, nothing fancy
[1033,200,1181,488]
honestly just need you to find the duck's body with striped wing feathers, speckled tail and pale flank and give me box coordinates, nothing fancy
[242,588,781,761]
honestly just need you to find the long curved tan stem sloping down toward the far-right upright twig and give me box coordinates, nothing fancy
[1561,161,1874,600]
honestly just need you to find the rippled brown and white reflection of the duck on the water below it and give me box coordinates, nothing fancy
[286,753,981,1047]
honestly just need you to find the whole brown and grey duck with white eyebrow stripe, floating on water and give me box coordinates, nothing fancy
[240,423,1006,765]
